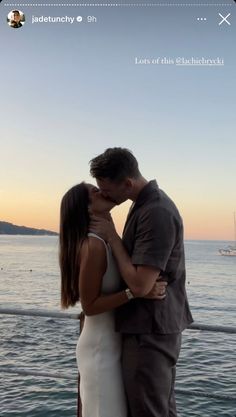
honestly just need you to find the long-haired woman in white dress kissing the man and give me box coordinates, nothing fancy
[60,183,166,417]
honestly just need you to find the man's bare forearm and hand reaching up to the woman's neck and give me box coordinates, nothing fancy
[90,216,160,297]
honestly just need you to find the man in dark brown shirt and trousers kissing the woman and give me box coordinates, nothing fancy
[90,148,193,417]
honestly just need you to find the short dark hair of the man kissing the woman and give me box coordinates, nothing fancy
[90,148,141,182]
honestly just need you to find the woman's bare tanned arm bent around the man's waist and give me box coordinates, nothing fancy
[79,237,129,316]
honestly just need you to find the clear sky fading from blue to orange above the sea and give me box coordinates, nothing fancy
[0,0,236,240]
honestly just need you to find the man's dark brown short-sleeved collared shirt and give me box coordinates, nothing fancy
[116,180,193,334]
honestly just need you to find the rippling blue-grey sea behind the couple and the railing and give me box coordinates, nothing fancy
[0,235,236,417]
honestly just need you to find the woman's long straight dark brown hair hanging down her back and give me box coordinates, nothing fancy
[59,182,89,308]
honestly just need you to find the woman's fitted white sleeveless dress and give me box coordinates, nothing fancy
[76,233,127,417]
